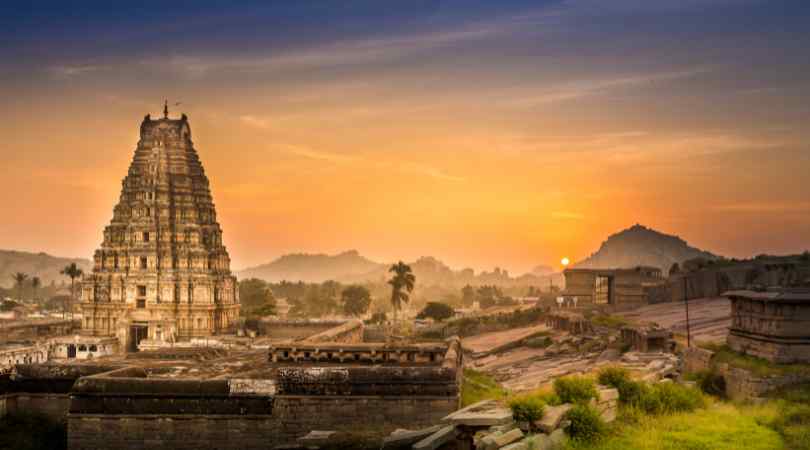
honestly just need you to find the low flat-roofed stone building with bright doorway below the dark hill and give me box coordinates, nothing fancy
[563,266,665,309]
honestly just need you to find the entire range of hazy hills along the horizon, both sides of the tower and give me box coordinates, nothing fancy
[0,225,717,287]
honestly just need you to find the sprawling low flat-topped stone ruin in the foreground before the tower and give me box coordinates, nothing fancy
[0,314,463,450]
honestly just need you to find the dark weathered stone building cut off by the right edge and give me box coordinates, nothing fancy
[724,288,810,363]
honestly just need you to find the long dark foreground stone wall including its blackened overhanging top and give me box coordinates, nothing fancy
[68,340,462,450]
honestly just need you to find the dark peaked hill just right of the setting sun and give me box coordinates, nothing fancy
[574,224,717,274]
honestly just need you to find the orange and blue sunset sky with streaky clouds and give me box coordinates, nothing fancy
[0,0,810,273]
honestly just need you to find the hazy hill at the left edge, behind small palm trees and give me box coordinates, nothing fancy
[0,250,92,287]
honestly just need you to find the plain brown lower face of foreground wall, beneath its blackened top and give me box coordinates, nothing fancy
[68,396,457,450]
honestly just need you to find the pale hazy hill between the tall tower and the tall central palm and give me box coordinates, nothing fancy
[237,250,384,282]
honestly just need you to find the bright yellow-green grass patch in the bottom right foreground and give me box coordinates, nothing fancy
[567,403,784,450]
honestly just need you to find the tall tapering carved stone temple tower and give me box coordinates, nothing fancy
[81,107,239,351]
